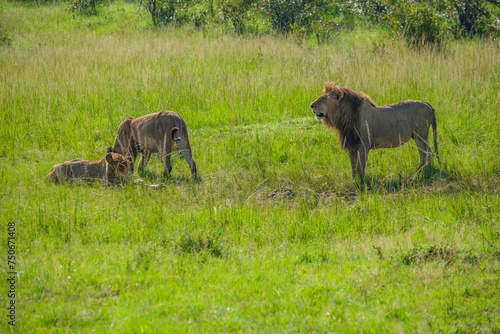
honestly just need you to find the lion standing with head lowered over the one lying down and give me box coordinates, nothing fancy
[108,111,197,176]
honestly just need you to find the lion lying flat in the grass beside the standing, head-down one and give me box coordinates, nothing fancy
[47,153,132,183]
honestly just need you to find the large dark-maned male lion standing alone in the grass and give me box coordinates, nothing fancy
[311,83,439,178]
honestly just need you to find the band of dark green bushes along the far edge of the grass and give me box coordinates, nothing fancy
[135,0,500,42]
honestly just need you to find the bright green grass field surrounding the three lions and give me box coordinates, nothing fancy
[0,0,500,333]
